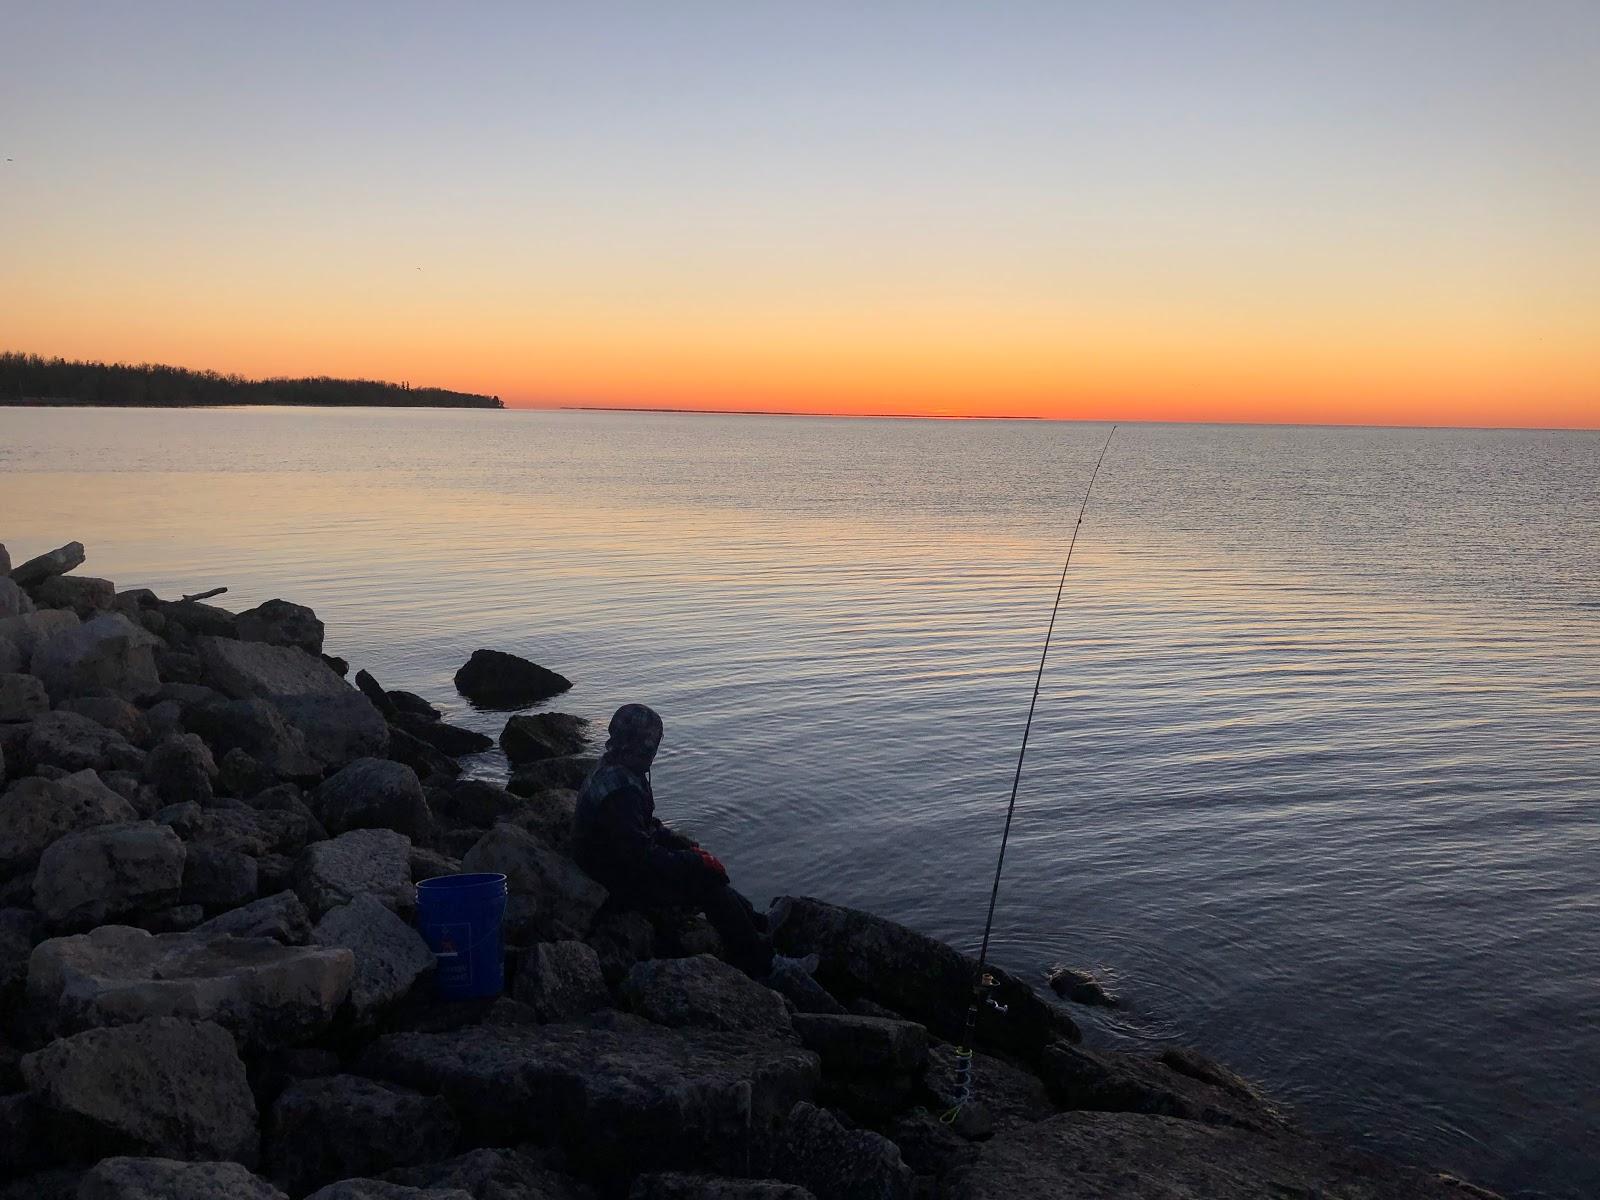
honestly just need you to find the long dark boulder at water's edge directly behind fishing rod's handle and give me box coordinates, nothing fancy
[774,898,1080,1056]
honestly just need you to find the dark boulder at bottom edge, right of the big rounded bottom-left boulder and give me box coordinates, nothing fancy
[266,1075,461,1195]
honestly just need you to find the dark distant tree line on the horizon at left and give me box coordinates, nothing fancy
[0,352,506,408]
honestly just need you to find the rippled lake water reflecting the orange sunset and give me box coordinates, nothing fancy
[0,408,1600,1197]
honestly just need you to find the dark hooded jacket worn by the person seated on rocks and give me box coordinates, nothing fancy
[573,704,709,904]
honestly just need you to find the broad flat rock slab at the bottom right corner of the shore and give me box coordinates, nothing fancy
[947,1112,1490,1200]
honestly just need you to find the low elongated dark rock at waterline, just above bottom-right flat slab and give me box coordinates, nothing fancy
[1038,1042,1283,1131]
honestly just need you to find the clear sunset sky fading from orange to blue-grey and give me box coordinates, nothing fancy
[0,0,1600,427]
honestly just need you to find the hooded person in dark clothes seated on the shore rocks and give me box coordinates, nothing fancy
[573,704,773,979]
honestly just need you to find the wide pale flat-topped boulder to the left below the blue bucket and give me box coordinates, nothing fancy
[27,925,355,1046]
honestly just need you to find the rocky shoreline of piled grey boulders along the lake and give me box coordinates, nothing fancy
[0,542,1490,1200]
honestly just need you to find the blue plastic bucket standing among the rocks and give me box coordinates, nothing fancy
[416,872,506,1000]
